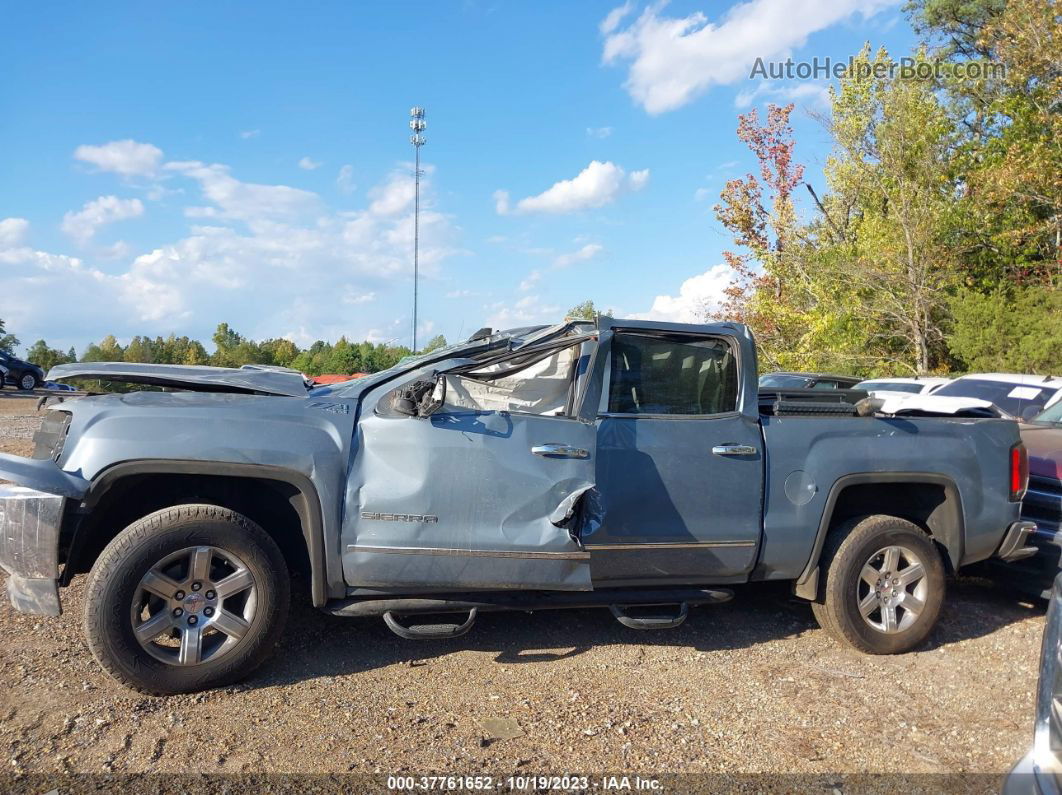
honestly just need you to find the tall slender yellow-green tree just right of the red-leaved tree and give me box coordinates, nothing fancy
[811,48,959,374]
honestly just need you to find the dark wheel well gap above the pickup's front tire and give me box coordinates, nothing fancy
[63,473,311,584]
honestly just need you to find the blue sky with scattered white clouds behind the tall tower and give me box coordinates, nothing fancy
[0,0,914,351]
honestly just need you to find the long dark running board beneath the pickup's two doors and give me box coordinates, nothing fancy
[321,588,734,619]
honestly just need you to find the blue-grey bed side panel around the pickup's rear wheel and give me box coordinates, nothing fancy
[757,417,1020,580]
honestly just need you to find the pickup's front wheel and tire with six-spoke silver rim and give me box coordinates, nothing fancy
[85,504,291,695]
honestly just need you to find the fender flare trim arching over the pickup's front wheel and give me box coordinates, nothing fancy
[81,459,328,607]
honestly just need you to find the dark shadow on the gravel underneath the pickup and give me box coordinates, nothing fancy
[250,577,1046,689]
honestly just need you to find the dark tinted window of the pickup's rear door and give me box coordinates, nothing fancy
[609,333,738,416]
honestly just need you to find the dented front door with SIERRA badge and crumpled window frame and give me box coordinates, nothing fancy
[342,335,597,592]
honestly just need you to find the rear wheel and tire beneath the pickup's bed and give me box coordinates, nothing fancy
[811,515,944,654]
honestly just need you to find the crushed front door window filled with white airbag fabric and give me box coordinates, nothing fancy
[444,345,581,416]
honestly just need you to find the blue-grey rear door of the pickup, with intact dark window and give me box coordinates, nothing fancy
[583,321,764,586]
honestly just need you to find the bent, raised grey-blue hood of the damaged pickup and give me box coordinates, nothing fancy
[48,362,308,397]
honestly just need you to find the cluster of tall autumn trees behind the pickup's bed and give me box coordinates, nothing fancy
[708,0,1062,376]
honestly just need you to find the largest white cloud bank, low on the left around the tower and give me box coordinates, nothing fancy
[0,150,460,347]
